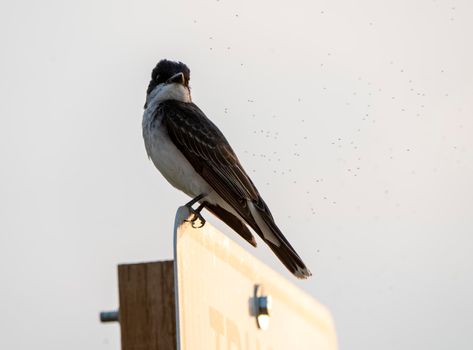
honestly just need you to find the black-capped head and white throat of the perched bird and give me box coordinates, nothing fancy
[145,59,190,108]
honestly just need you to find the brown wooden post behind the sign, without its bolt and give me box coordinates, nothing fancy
[118,260,177,350]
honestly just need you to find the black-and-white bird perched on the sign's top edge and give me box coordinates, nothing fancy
[142,59,312,279]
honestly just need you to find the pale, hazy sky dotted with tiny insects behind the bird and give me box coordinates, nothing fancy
[0,0,473,350]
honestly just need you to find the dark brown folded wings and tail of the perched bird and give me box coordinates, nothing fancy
[157,100,310,278]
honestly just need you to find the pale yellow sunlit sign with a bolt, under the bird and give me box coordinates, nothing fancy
[174,207,337,350]
